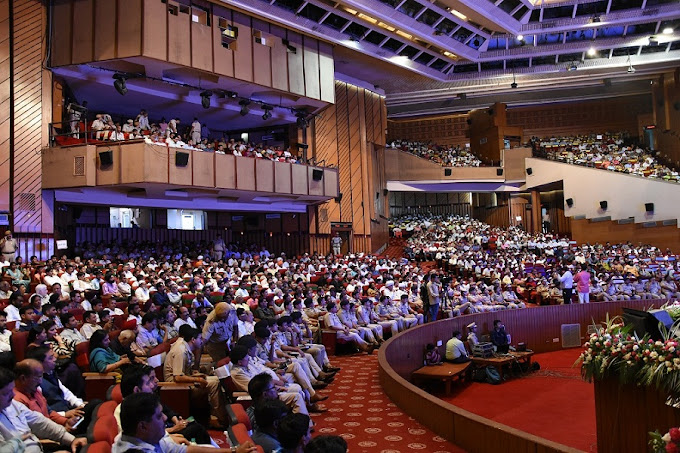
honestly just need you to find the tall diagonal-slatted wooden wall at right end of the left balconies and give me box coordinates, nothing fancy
[310,81,389,253]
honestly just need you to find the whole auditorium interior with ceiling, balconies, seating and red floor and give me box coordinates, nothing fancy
[0,0,680,453]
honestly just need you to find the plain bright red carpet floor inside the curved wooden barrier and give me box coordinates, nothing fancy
[442,348,597,452]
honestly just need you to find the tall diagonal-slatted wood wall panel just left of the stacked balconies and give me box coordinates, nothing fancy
[12,0,46,233]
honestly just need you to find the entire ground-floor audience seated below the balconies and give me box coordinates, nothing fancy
[0,207,680,452]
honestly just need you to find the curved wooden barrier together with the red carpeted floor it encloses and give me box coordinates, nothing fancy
[378,301,665,453]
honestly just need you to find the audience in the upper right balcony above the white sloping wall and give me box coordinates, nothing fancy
[531,133,679,182]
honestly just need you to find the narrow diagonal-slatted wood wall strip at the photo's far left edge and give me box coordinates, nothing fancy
[0,0,11,211]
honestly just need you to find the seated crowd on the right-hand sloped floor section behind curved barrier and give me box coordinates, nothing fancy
[393,216,680,306]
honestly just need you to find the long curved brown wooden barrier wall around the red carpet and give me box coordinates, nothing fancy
[378,300,666,452]
